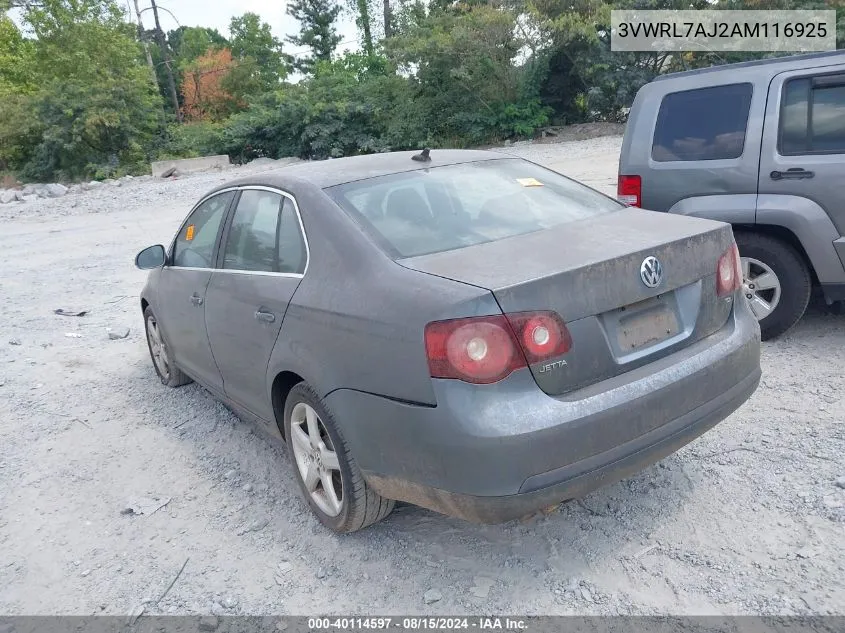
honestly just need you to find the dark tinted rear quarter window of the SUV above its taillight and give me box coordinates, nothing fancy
[651,84,752,162]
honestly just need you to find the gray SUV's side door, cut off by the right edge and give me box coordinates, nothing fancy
[759,65,845,235]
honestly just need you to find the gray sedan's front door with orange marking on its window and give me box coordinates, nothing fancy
[156,191,235,391]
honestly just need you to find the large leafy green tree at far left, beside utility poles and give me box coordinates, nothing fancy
[5,0,162,180]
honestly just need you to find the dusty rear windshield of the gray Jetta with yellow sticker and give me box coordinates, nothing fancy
[326,158,625,258]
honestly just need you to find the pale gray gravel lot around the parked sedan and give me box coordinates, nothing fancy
[0,137,845,615]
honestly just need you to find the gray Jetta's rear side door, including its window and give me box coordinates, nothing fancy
[205,187,308,421]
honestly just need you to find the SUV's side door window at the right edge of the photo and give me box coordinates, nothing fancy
[778,75,845,156]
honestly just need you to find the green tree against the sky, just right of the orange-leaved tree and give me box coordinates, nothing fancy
[229,13,291,92]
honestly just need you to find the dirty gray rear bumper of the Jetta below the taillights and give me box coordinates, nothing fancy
[326,301,760,522]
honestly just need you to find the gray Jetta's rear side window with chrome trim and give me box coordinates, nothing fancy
[223,189,306,273]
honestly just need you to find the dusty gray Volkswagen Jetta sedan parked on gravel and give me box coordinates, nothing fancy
[136,150,760,532]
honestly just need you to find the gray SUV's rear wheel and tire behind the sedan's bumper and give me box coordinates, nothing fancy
[736,232,813,341]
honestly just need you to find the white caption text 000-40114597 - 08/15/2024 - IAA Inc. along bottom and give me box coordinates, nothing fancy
[308,616,528,631]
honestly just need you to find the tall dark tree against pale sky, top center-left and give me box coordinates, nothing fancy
[287,0,341,73]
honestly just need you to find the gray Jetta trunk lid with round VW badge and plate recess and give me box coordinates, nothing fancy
[399,208,733,395]
